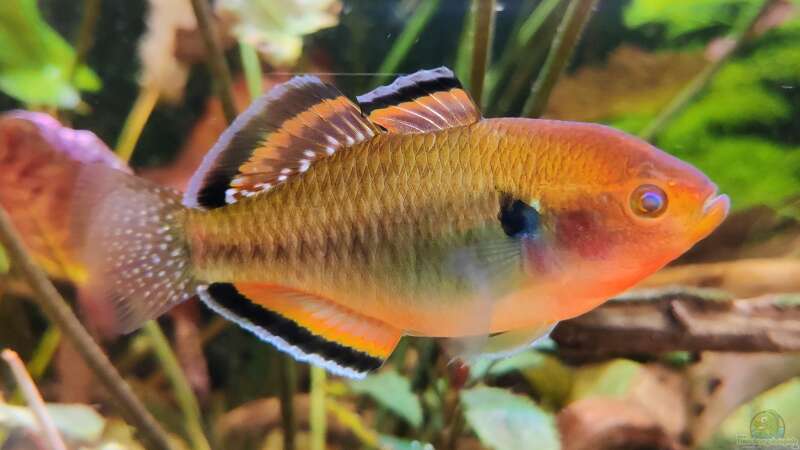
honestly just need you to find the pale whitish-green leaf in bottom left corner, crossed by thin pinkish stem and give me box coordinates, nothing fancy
[0,404,105,442]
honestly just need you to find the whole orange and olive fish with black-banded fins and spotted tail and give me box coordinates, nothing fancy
[71,67,730,378]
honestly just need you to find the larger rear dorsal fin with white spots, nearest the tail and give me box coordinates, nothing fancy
[184,76,379,208]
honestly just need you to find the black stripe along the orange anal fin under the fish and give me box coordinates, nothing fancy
[208,283,383,372]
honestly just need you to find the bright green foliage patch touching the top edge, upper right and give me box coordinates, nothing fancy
[624,0,762,42]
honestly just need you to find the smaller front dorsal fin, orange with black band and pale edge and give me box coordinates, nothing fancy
[358,67,481,133]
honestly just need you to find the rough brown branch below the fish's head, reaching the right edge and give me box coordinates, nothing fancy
[552,291,800,356]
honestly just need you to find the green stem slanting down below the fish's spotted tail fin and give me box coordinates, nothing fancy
[142,320,211,450]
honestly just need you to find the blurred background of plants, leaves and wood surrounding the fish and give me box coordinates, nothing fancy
[0,0,800,450]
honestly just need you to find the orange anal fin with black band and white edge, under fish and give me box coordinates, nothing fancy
[198,283,402,378]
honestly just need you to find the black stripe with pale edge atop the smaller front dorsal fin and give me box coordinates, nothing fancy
[357,67,462,115]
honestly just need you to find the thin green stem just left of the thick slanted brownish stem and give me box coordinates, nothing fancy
[486,0,561,110]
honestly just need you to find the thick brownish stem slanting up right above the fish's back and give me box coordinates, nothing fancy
[522,0,597,117]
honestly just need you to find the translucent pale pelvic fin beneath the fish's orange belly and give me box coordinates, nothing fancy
[443,323,556,361]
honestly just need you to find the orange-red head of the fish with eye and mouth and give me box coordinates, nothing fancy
[510,121,730,296]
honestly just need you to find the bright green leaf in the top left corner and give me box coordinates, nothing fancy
[0,0,100,109]
